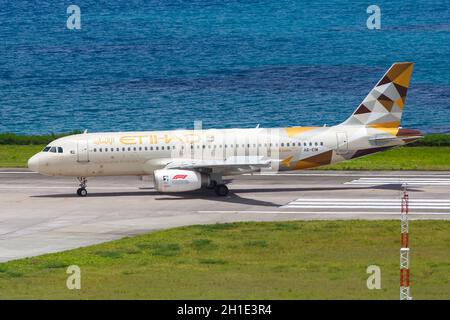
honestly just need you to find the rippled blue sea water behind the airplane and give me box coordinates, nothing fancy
[0,0,450,134]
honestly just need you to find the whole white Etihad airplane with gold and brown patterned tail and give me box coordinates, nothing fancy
[28,62,423,197]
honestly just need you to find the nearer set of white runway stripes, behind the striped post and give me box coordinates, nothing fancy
[281,198,450,211]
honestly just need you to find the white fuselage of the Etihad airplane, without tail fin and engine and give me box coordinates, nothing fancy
[29,126,410,177]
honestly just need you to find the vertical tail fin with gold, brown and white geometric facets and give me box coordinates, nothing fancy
[342,62,413,128]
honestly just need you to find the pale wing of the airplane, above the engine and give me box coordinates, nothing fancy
[165,156,271,172]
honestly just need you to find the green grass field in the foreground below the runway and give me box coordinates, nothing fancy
[0,220,450,300]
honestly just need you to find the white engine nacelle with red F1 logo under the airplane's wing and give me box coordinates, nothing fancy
[153,169,210,192]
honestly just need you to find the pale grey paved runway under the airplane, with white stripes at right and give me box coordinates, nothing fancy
[0,169,450,261]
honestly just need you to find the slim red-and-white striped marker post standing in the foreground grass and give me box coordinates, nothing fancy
[400,183,411,300]
